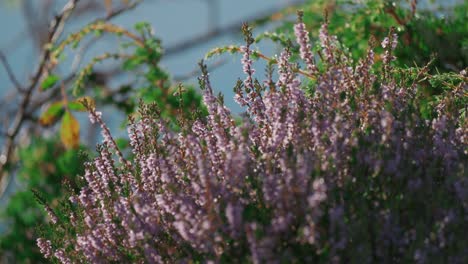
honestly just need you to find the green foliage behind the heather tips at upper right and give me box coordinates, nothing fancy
[268,0,468,72]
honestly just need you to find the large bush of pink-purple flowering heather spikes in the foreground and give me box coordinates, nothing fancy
[38,17,468,263]
